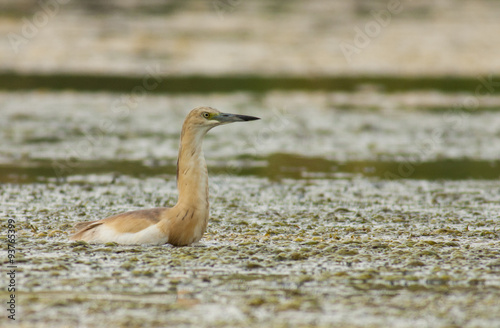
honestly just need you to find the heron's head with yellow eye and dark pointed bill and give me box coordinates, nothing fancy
[184,107,260,131]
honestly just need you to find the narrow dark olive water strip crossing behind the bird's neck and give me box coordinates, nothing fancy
[0,153,500,183]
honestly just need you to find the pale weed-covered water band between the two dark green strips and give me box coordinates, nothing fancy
[0,90,500,165]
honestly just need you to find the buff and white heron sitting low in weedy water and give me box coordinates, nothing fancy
[70,107,260,246]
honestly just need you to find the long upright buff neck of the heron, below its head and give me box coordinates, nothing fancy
[176,125,209,210]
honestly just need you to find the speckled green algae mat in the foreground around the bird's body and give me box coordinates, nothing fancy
[1,175,500,327]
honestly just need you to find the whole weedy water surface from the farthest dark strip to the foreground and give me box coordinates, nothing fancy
[0,90,500,327]
